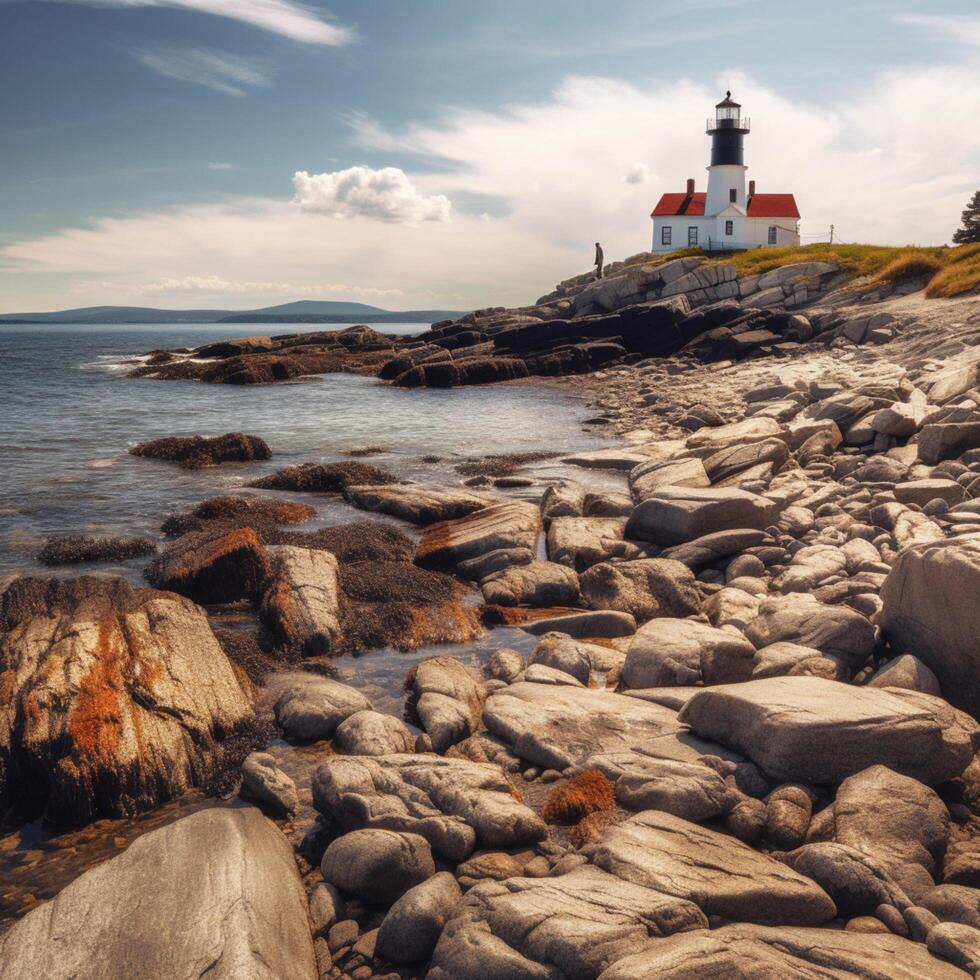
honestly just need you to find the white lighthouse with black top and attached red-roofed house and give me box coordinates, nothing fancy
[650,92,800,252]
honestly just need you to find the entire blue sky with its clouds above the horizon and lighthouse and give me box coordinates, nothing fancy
[0,0,980,311]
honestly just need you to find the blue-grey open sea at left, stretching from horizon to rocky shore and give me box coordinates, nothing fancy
[0,324,602,577]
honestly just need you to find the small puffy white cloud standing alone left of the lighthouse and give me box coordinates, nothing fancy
[293,167,452,222]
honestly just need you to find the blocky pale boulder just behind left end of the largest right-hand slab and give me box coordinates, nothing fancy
[623,618,755,688]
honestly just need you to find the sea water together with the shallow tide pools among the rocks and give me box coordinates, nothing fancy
[0,324,622,920]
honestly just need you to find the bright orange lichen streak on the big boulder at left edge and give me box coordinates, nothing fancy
[68,615,124,769]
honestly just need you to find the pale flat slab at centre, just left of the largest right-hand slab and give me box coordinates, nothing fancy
[483,682,681,771]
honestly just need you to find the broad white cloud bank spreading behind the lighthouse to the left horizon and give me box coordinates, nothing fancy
[0,59,980,309]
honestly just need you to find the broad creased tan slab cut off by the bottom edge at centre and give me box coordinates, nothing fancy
[427,867,707,980]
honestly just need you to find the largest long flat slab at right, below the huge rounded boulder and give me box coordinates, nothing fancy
[679,677,978,785]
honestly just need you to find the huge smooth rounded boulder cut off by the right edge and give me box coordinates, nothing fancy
[881,534,980,717]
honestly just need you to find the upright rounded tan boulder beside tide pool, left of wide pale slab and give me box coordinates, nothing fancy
[411,657,483,752]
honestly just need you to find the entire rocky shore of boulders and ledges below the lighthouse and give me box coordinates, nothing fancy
[0,258,980,980]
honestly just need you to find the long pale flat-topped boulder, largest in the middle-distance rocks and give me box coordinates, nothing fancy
[624,487,779,545]
